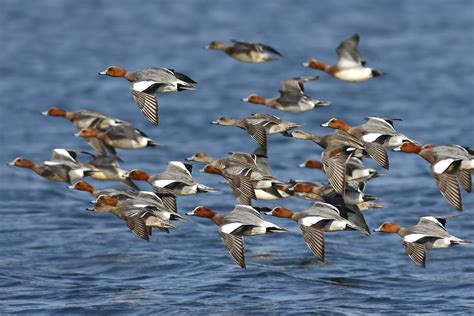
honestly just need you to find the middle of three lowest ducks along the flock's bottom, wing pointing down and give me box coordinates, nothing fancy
[265,202,361,262]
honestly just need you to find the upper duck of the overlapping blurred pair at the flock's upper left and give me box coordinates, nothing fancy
[41,107,130,130]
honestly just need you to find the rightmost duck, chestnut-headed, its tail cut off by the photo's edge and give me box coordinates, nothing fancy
[393,141,474,211]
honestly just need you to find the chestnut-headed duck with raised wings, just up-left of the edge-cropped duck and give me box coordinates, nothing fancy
[321,117,411,148]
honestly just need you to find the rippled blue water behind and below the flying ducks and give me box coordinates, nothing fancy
[0,0,474,314]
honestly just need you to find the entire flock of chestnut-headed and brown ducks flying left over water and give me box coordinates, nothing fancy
[10,34,474,268]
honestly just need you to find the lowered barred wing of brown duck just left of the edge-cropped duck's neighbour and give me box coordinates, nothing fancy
[322,147,350,196]
